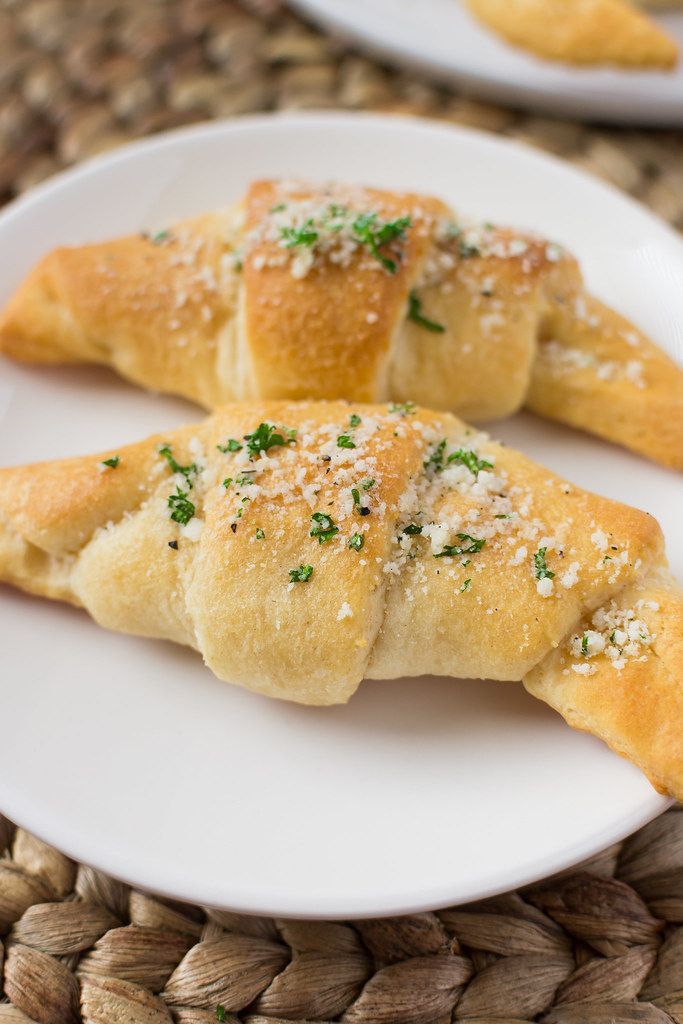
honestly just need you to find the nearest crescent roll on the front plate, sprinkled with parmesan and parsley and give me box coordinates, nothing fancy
[0,402,683,797]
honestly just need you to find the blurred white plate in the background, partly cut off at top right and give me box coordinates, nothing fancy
[291,0,683,125]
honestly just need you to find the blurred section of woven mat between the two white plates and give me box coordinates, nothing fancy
[0,0,683,227]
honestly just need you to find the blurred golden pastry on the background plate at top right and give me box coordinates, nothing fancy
[467,0,678,70]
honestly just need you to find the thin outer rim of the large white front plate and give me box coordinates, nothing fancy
[0,111,683,920]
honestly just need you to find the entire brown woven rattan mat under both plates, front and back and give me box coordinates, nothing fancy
[0,0,683,1024]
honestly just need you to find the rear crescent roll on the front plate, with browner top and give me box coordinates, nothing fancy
[0,181,683,468]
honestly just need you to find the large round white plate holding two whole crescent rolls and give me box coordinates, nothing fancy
[0,114,683,918]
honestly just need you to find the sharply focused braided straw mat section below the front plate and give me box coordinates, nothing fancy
[0,808,683,1024]
